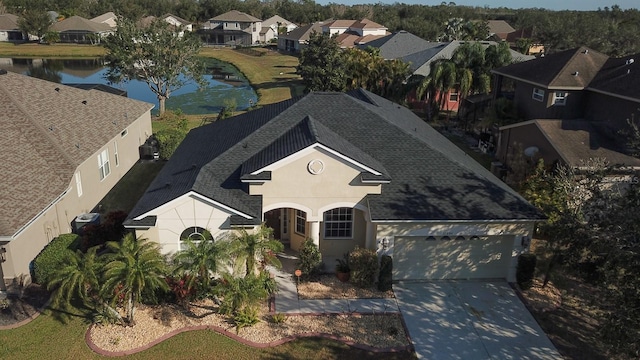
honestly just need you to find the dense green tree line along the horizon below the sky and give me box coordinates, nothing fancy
[0,0,640,56]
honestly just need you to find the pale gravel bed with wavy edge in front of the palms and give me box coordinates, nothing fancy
[90,302,409,352]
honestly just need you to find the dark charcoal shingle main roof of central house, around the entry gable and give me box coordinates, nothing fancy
[129,90,541,222]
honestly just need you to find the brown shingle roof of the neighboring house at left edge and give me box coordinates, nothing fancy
[0,72,153,236]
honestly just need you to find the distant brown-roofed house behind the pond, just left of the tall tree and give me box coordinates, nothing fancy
[50,15,113,44]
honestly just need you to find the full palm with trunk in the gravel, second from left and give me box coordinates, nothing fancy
[102,234,168,324]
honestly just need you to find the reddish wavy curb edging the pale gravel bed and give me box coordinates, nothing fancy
[85,313,414,357]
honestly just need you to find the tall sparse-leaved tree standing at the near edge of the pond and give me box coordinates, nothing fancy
[103,18,205,115]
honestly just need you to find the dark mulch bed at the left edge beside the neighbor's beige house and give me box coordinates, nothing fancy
[0,284,49,327]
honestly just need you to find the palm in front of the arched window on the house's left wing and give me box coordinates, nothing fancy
[174,236,229,291]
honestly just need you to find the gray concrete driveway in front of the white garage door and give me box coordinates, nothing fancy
[393,281,562,360]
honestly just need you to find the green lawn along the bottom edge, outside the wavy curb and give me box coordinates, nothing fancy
[0,315,415,360]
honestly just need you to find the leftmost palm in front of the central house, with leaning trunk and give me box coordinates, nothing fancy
[47,246,122,323]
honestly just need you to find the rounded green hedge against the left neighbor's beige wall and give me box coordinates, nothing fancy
[31,234,80,288]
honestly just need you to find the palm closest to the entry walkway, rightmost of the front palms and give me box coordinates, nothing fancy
[230,224,284,276]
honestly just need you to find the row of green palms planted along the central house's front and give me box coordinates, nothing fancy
[46,225,283,325]
